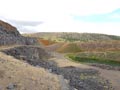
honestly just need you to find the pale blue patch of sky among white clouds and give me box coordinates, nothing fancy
[72,8,120,23]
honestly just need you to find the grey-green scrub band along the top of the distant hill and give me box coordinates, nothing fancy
[60,33,120,42]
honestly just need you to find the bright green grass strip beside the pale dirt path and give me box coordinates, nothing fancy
[67,54,120,66]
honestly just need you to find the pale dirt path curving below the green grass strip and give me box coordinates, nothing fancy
[51,53,120,90]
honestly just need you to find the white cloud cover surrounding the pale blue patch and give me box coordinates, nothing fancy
[0,0,120,35]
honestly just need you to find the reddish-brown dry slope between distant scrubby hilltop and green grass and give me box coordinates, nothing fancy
[47,41,120,53]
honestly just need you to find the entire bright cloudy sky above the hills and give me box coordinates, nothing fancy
[0,0,120,36]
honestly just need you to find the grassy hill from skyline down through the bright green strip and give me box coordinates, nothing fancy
[23,32,120,65]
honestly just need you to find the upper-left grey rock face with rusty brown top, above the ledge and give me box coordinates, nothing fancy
[0,20,37,46]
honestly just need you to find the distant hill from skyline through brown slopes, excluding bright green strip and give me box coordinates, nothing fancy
[25,32,120,53]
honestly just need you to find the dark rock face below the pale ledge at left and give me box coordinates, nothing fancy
[2,46,51,63]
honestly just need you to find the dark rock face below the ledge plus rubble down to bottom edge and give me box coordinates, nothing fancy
[2,46,112,90]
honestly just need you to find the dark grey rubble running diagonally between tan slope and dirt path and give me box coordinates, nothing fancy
[2,48,113,90]
